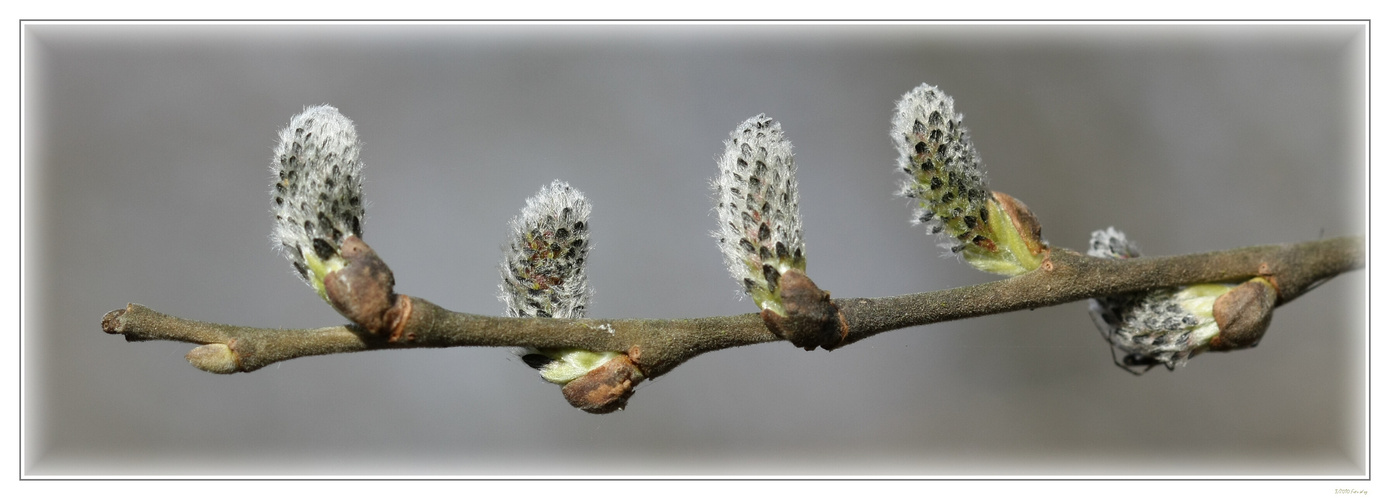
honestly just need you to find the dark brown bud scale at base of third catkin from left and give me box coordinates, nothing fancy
[762,268,849,350]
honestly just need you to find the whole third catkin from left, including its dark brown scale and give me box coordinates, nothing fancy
[710,115,844,350]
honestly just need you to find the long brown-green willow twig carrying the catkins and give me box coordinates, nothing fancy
[101,236,1365,378]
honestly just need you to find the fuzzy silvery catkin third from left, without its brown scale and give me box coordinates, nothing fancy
[710,114,806,308]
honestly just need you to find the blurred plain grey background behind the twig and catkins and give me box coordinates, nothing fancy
[24,25,1368,475]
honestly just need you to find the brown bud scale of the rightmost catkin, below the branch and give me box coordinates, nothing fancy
[1211,278,1277,351]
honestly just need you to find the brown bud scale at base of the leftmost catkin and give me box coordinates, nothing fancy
[324,235,410,340]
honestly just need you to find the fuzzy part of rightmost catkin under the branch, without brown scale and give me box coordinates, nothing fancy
[1087,228,1232,369]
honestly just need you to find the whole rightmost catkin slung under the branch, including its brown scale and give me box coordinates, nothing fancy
[1087,228,1275,375]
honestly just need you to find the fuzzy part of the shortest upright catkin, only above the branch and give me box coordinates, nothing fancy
[499,181,591,318]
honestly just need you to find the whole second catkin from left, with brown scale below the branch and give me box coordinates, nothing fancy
[498,181,642,413]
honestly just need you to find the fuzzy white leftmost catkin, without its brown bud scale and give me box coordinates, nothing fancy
[270,104,366,286]
